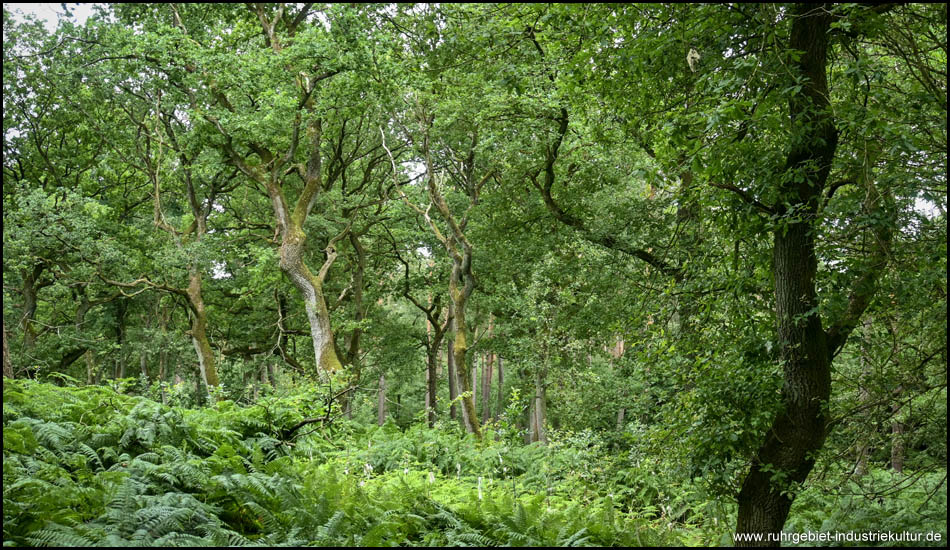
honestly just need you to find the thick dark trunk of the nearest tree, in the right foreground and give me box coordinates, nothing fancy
[736,4,837,546]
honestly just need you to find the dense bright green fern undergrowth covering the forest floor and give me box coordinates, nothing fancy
[3,380,946,546]
